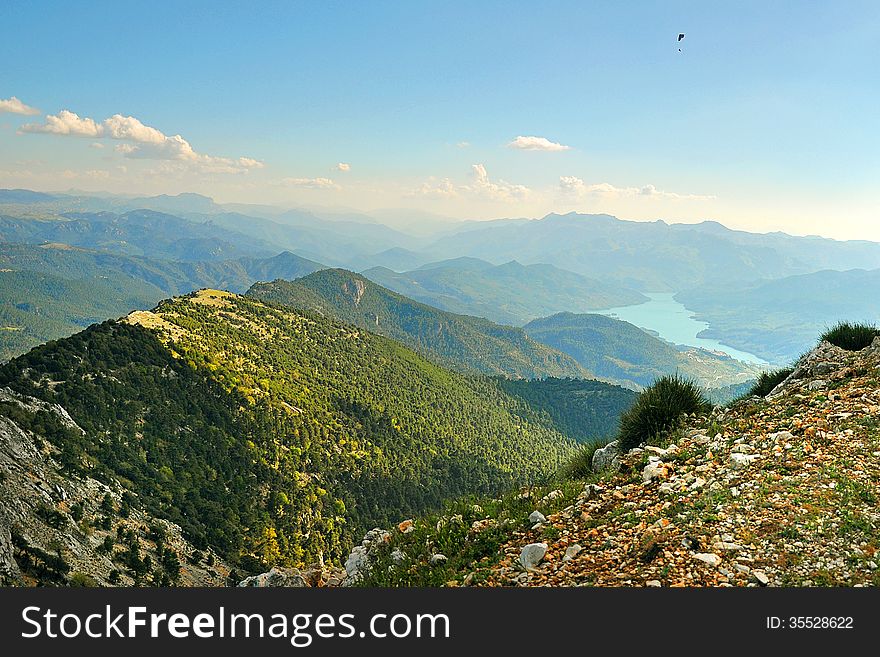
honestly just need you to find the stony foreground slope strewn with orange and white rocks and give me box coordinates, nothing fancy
[350,338,880,586]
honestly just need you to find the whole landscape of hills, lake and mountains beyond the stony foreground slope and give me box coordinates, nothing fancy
[0,190,880,586]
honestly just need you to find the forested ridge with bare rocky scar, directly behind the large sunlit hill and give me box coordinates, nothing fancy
[247,269,590,378]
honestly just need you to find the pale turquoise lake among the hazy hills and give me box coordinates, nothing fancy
[597,292,767,365]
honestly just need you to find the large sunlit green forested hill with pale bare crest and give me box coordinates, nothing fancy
[0,291,572,569]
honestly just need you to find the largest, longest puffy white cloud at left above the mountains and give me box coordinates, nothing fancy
[19,110,264,173]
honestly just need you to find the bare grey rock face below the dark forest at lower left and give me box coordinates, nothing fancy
[0,388,229,586]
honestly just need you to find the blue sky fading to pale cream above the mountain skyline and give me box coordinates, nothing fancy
[0,0,880,239]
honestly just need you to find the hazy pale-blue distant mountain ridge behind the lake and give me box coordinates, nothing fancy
[427,213,880,292]
